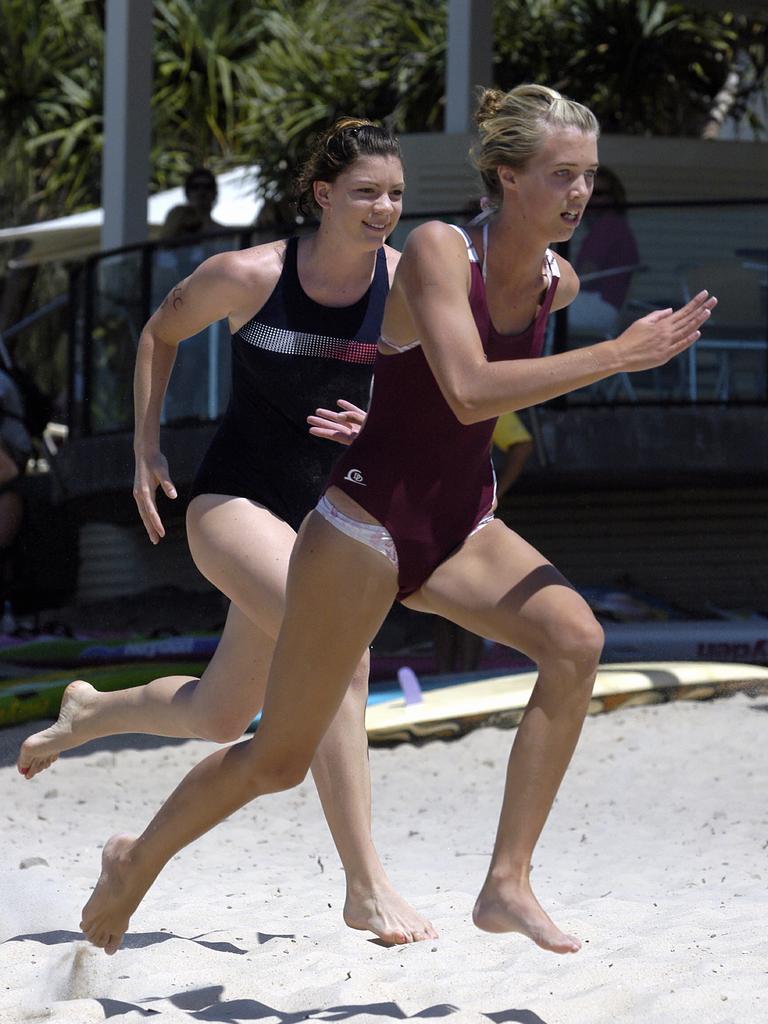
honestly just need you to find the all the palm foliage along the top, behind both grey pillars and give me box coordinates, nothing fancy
[0,0,768,230]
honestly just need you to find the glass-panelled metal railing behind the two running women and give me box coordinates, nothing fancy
[69,201,768,435]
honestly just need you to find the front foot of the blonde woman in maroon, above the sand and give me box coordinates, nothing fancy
[472,878,582,953]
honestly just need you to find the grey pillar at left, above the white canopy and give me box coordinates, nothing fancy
[101,0,153,249]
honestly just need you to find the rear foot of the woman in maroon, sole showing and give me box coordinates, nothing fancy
[80,835,153,956]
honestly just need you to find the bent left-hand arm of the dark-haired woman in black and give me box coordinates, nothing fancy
[133,253,258,544]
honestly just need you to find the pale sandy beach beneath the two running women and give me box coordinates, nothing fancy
[0,694,768,1024]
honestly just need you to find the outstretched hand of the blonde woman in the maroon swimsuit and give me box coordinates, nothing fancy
[614,292,718,372]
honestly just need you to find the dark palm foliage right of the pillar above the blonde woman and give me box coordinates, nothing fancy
[496,0,766,136]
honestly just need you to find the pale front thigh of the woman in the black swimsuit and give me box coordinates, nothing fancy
[186,495,296,638]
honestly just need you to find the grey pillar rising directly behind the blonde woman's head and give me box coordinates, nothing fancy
[444,0,494,133]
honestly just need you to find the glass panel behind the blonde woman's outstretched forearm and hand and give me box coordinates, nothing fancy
[566,204,768,404]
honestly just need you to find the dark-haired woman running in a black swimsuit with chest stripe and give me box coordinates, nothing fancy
[18,118,435,942]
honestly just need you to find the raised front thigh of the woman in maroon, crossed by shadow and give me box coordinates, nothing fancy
[403,519,592,660]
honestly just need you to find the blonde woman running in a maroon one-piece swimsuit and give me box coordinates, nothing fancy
[83,86,715,953]
